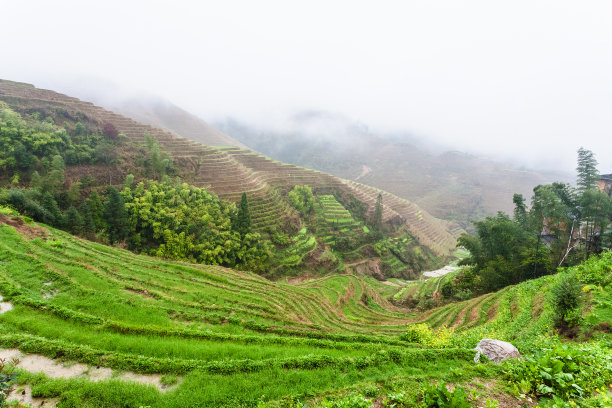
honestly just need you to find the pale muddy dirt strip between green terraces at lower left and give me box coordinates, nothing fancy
[0,349,176,395]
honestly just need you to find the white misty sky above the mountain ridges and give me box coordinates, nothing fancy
[0,0,612,173]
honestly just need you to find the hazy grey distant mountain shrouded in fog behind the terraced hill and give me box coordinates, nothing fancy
[214,111,570,229]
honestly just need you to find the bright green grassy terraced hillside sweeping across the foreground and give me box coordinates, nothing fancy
[0,210,609,407]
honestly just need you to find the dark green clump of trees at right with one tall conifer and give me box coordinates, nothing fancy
[449,148,612,293]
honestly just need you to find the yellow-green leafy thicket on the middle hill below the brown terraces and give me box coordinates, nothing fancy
[123,181,269,270]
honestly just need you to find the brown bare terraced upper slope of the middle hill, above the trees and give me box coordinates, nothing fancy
[0,81,461,257]
